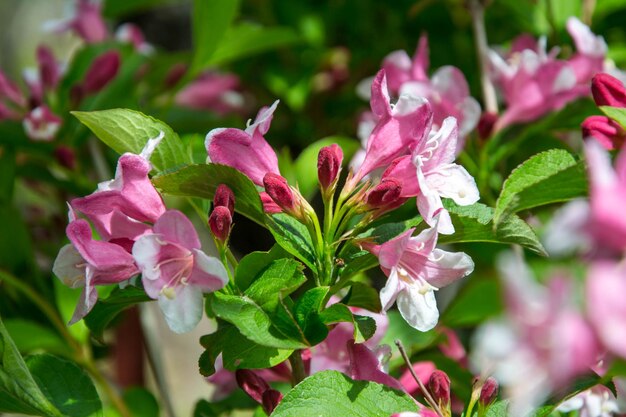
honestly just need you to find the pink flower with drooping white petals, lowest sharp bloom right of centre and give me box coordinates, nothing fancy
[366,219,474,332]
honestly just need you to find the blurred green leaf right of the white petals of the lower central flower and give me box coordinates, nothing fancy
[441,275,504,328]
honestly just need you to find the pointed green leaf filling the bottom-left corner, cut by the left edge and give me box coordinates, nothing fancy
[0,320,64,417]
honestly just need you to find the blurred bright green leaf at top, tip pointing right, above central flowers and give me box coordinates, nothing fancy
[209,22,300,65]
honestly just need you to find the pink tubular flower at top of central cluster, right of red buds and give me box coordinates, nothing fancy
[352,70,432,184]
